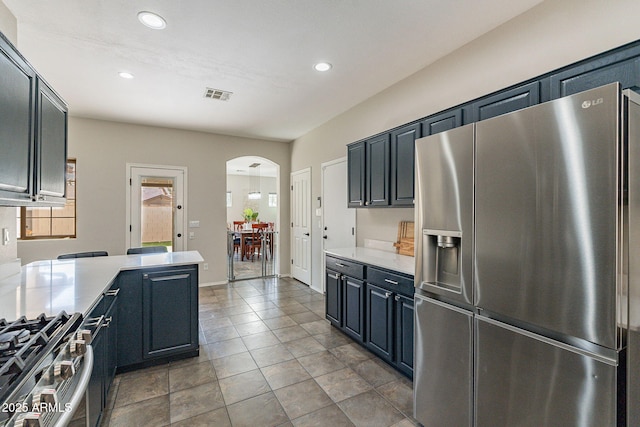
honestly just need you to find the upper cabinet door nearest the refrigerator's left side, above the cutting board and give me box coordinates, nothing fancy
[391,123,421,206]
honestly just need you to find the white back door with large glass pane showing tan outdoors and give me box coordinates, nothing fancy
[126,164,187,251]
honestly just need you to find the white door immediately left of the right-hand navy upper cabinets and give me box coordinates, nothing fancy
[322,157,356,292]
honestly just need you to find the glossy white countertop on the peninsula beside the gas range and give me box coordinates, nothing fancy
[0,251,204,321]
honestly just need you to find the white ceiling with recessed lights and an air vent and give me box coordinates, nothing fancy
[2,0,542,141]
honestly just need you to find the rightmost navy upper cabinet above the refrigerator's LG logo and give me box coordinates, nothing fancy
[550,47,640,99]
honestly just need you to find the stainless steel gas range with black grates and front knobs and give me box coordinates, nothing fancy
[0,311,93,427]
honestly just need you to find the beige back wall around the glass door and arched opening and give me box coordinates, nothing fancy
[18,117,290,283]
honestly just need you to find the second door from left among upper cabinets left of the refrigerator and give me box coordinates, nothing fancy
[364,134,390,206]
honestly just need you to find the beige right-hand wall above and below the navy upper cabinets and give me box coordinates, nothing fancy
[291,0,640,286]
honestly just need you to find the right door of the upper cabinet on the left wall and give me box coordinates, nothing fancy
[35,80,67,203]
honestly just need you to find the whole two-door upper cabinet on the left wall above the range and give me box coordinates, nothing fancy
[0,33,67,206]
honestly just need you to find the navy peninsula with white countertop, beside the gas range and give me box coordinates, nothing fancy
[0,251,203,426]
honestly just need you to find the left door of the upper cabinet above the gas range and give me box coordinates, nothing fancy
[0,35,36,203]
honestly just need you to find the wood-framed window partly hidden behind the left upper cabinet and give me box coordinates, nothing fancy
[18,159,76,240]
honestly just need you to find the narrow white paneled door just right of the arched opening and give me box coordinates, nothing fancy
[291,168,311,285]
